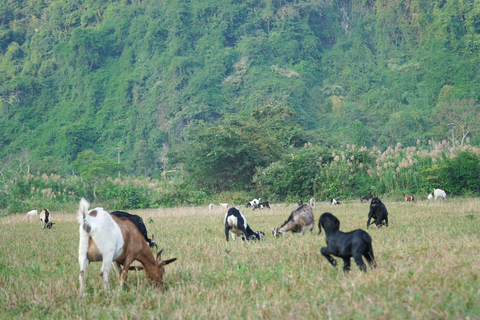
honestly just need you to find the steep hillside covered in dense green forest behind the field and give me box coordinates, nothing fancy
[0,0,480,210]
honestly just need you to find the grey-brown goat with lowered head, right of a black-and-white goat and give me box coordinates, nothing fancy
[272,204,315,237]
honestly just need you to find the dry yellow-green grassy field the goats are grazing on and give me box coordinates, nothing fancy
[0,198,480,319]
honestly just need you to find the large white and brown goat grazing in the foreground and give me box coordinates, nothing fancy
[77,198,177,295]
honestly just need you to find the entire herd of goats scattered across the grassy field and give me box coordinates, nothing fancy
[26,189,446,295]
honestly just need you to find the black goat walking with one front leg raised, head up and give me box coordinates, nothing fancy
[318,212,377,274]
